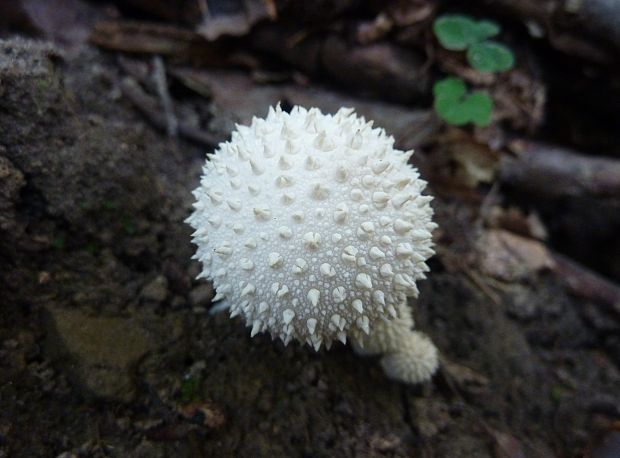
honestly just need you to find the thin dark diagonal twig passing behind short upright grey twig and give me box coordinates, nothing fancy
[120,77,220,147]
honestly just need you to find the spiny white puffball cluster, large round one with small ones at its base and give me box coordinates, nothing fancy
[187,105,437,382]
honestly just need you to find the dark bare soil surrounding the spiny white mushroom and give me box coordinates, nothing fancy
[0,2,620,458]
